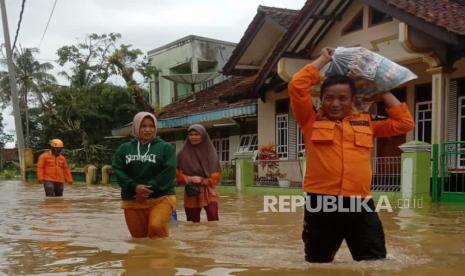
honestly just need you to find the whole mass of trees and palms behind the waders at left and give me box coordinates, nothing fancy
[0,33,153,166]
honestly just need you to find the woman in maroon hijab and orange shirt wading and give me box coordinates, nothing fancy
[176,124,221,222]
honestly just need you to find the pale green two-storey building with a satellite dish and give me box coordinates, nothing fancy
[148,35,236,109]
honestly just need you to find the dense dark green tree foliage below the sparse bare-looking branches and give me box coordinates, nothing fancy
[31,84,138,165]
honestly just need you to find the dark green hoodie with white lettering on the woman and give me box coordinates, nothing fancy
[112,137,176,200]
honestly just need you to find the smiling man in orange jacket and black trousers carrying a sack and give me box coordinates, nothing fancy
[288,48,414,263]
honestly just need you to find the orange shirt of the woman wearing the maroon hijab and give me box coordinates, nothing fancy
[176,170,221,208]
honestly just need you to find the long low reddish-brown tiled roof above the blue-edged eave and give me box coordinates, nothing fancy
[156,77,257,119]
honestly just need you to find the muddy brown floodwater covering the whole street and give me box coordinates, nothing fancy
[0,181,465,276]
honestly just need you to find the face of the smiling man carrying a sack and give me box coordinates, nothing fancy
[321,84,354,121]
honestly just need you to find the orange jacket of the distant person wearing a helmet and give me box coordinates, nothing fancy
[37,150,73,183]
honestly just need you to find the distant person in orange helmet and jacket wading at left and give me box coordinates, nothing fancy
[37,139,73,196]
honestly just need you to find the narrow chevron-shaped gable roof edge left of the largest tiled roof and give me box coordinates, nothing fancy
[223,6,299,75]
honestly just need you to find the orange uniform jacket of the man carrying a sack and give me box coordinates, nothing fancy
[288,64,414,197]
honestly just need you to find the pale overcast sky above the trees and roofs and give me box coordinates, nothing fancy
[0,0,305,147]
